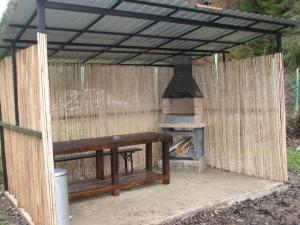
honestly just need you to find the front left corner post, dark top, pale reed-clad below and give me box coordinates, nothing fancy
[37,0,57,225]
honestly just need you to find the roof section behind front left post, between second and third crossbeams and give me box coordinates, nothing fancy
[21,29,76,42]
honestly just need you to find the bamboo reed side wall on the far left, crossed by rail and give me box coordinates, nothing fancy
[0,46,55,225]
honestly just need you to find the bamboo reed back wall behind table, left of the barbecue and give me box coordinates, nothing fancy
[49,64,160,180]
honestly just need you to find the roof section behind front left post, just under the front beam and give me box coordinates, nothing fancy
[32,9,100,30]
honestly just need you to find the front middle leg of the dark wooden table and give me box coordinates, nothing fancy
[110,148,120,196]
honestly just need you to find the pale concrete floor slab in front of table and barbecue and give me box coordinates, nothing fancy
[70,169,285,225]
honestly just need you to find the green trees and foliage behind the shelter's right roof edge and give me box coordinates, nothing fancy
[232,0,300,71]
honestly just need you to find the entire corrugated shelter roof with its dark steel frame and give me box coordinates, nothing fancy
[0,0,294,65]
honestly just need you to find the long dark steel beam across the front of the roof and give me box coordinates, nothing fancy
[45,1,277,34]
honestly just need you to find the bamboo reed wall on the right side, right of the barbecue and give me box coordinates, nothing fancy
[193,54,288,181]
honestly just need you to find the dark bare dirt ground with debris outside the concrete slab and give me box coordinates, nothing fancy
[0,173,300,225]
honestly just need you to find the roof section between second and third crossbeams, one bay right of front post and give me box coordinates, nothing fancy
[74,33,126,45]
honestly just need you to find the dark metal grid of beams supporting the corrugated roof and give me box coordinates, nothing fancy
[0,0,294,65]
